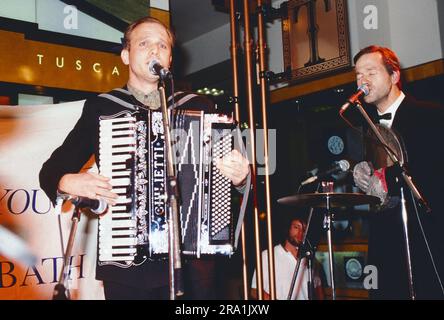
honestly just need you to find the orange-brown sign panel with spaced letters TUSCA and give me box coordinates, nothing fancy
[0,30,128,92]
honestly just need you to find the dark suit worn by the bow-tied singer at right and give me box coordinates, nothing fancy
[369,96,444,299]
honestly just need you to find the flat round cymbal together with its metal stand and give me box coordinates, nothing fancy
[278,190,380,300]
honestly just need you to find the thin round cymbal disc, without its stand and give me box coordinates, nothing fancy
[278,193,381,208]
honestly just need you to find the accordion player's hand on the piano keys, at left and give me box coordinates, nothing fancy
[58,172,118,205]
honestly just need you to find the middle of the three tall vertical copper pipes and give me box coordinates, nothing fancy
[243,0,263,300]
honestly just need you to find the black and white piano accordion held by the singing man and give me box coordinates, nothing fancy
[98,110,234,265]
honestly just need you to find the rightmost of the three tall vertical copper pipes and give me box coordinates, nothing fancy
[257,0,276,300]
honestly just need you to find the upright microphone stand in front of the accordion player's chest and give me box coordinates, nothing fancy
[159,77,184,300]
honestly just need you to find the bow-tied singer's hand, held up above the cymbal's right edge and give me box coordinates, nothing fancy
[353,161,387,204]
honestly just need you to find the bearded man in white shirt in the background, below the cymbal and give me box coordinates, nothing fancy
[251,217,324,300]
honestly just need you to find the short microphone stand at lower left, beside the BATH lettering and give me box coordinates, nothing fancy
[52,205,80,300]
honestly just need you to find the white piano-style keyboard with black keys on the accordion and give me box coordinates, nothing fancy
[99,117,137,261]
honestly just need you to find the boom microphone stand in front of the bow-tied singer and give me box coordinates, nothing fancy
[350,101,431,300]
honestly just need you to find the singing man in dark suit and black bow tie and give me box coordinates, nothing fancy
[354,46,444,299]
